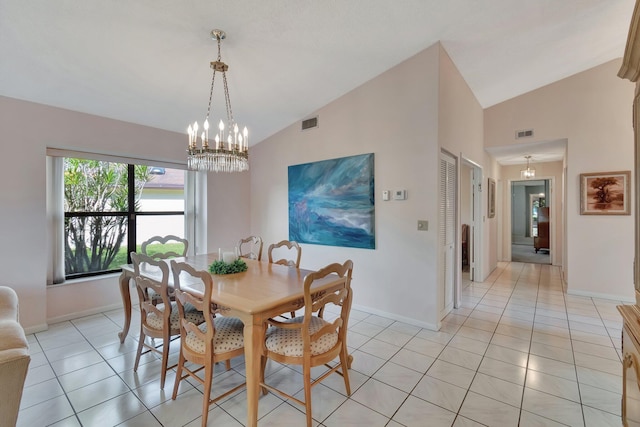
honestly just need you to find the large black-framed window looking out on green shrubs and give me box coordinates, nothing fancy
[64,158,185,279]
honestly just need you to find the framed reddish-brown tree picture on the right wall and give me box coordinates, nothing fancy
[580,171,631,215]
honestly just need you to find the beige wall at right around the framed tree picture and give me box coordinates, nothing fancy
[485,60,634,300]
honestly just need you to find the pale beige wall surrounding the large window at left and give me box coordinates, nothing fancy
[0,97,249,331]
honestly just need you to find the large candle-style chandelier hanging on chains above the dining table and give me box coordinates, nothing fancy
[187,30,249,172]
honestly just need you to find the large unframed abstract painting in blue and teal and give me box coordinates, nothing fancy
[289,153,376,249]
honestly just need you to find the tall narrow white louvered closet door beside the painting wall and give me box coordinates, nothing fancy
[438,152,458,319]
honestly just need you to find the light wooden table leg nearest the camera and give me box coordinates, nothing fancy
[244,319,264,427]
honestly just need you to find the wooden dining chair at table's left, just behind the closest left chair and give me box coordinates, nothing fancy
[131,252,204,388]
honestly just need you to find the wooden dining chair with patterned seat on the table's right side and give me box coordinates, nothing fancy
[260,260,353,427]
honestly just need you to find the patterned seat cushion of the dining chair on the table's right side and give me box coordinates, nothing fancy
[265,316,338,357]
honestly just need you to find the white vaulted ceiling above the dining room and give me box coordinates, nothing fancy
[0,0,634,161]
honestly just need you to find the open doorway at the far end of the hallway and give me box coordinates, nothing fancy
[511,179,553,264]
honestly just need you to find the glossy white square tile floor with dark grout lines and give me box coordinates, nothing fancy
[18,263,622,427]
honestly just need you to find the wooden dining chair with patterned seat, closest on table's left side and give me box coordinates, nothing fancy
[171,260,246,427]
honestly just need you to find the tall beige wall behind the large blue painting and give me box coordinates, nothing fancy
[251,45,482,328]
